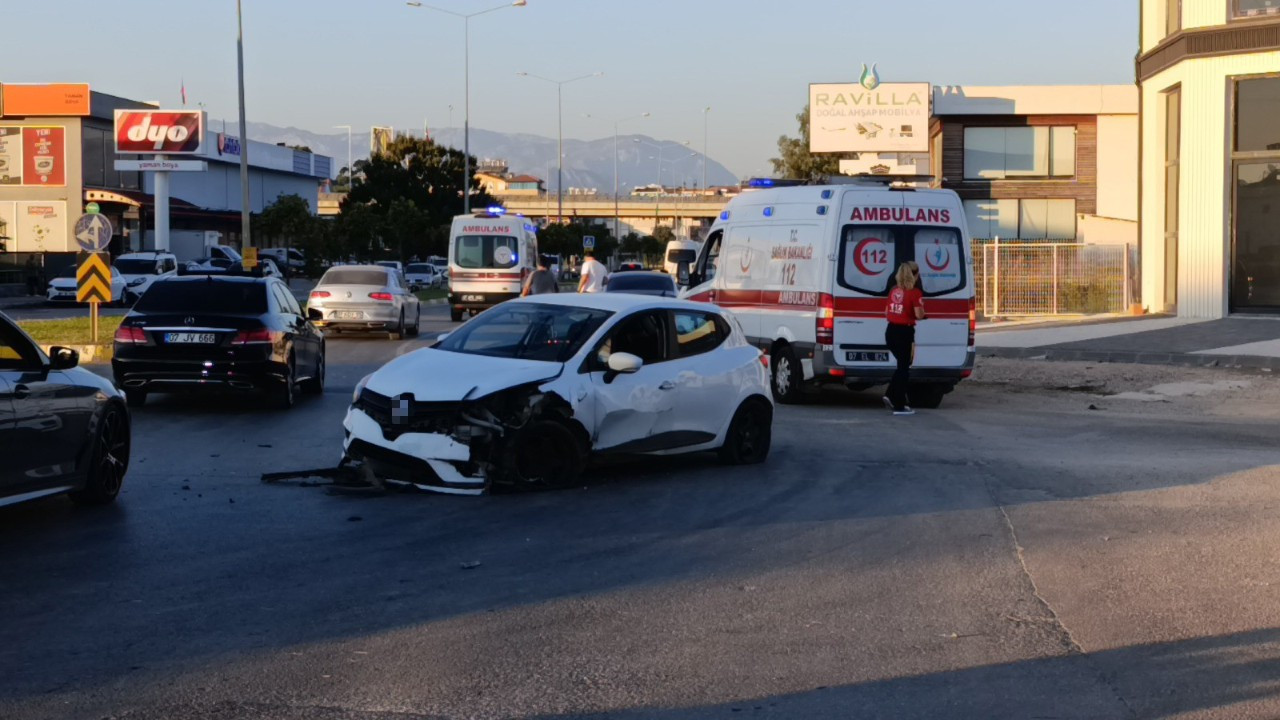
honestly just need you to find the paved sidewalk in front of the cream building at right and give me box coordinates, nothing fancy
[978,316,1280,370]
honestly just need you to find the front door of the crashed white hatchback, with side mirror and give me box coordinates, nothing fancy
[588,310,677,452]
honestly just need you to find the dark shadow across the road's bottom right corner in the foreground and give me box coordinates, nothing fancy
[529,628,1280,720]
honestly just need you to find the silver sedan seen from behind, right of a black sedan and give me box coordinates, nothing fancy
[307,265,422,337]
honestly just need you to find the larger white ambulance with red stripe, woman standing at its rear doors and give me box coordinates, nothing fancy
[682,178,975,407]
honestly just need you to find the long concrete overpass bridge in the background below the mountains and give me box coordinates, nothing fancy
[499,193,730,237]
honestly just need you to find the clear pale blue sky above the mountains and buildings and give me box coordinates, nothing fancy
[0,0,1138,176]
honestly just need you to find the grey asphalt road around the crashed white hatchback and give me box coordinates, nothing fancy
[0,307,1280,720]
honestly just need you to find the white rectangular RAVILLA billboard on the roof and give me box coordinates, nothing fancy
[809,82,933,152]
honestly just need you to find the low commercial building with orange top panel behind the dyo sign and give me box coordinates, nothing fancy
[0,85,332,275]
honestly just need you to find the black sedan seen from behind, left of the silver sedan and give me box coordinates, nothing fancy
[111,275,325,407]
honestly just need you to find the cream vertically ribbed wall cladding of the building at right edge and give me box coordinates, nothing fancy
[1140,50,1280,318]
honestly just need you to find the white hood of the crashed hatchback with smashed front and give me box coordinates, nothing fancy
[365,347,564,402]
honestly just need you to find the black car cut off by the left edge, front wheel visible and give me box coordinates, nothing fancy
[0,313,129,505]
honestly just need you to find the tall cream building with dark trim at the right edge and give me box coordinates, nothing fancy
[1137,0,1280,318]
